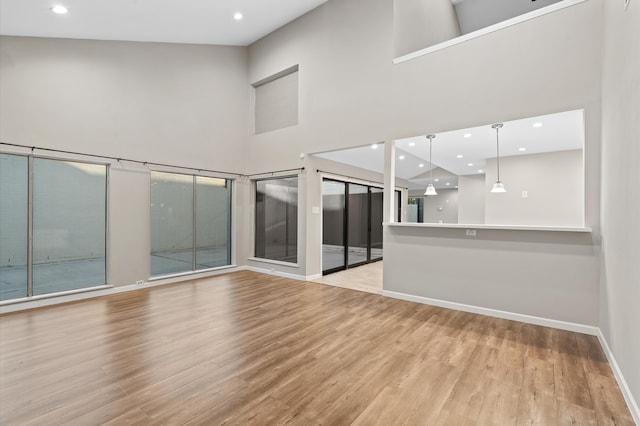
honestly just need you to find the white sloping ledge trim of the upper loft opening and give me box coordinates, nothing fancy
[393,0,587,65]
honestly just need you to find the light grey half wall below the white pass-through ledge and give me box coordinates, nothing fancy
[383,226,599,326]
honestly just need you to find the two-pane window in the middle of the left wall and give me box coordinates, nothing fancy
[151,172,231,276]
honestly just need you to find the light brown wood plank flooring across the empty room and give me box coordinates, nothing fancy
[0,271,633,425]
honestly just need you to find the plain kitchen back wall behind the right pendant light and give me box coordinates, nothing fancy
[484,150,584,226]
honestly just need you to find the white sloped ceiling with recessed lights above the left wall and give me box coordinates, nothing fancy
[0,0,327,46]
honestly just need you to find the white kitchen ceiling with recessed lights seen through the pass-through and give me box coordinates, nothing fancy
[315,110,584,188]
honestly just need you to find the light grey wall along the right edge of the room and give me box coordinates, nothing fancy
[600,0,640,416]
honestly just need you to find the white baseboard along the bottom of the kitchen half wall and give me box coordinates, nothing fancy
[381,290,599,336]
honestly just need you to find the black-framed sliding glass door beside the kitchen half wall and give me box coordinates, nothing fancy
[322,179,383,274]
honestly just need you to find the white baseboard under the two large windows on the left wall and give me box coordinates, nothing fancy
[0,266,242,315]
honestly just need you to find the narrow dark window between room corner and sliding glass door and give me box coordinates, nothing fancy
[255,177,298,263]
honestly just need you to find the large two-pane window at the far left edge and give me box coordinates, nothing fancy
[0,154,107,300]
